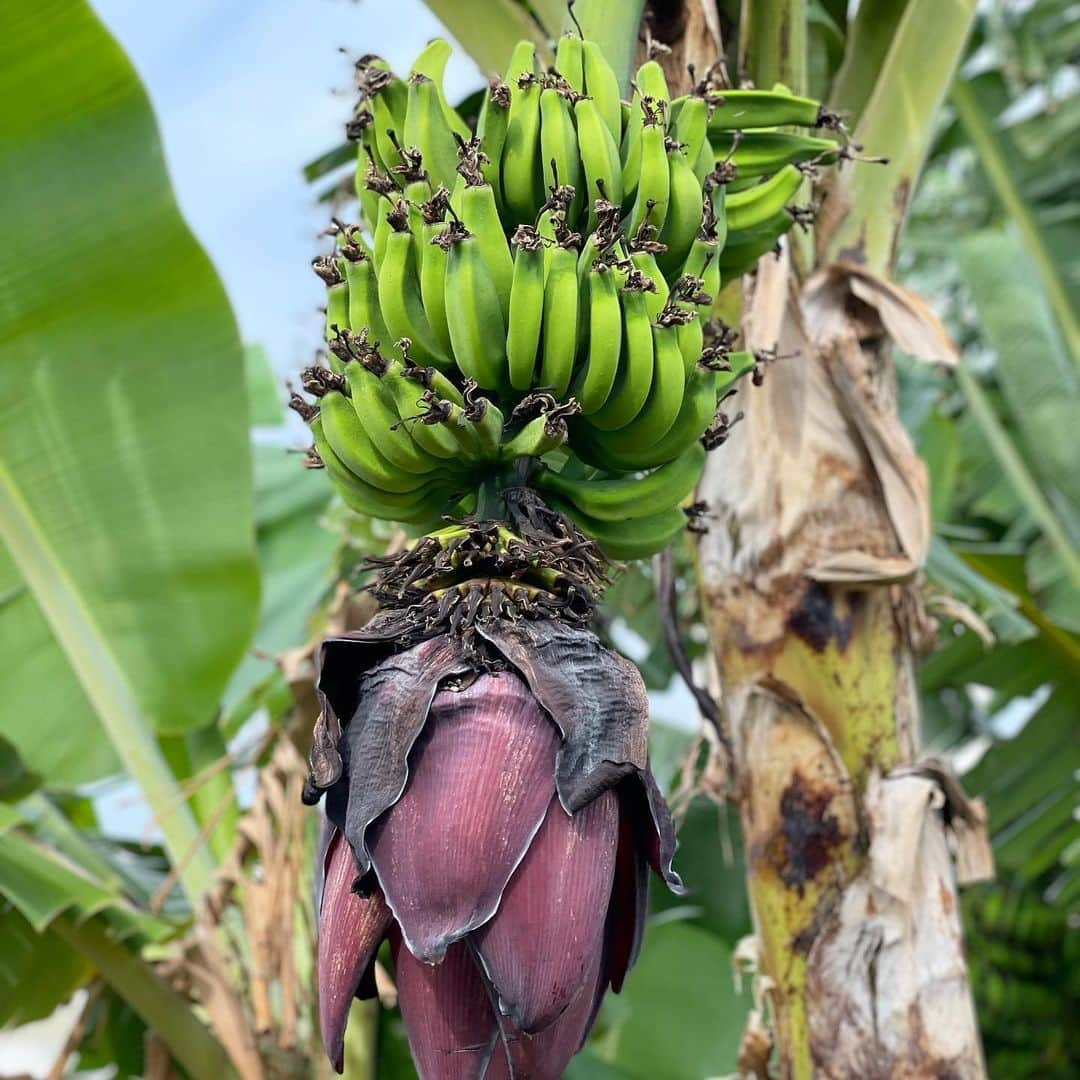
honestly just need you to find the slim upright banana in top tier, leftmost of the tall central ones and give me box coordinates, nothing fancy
[500,41,544,225]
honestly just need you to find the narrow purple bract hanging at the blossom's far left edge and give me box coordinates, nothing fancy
[319,831,392,1072]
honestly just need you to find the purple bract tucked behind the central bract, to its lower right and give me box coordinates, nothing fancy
[473,792,619,1032]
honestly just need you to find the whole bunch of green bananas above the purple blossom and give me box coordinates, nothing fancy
[301,33,845,558]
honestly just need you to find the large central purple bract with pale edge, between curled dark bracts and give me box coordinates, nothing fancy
[369,672,558,961]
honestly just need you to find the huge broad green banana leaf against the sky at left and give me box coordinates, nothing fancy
[0,0,258,803]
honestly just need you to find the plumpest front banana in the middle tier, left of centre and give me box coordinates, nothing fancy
[446,222,508,390]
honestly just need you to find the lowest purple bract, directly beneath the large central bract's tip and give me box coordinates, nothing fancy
[393,941,499,1080]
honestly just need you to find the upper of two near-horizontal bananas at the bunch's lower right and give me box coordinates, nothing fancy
[537,442,705,522]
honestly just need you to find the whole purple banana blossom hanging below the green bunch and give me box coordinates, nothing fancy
[312,621,681,1080]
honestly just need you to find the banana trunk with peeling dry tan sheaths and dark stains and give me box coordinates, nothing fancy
[643,0,988,1078]
